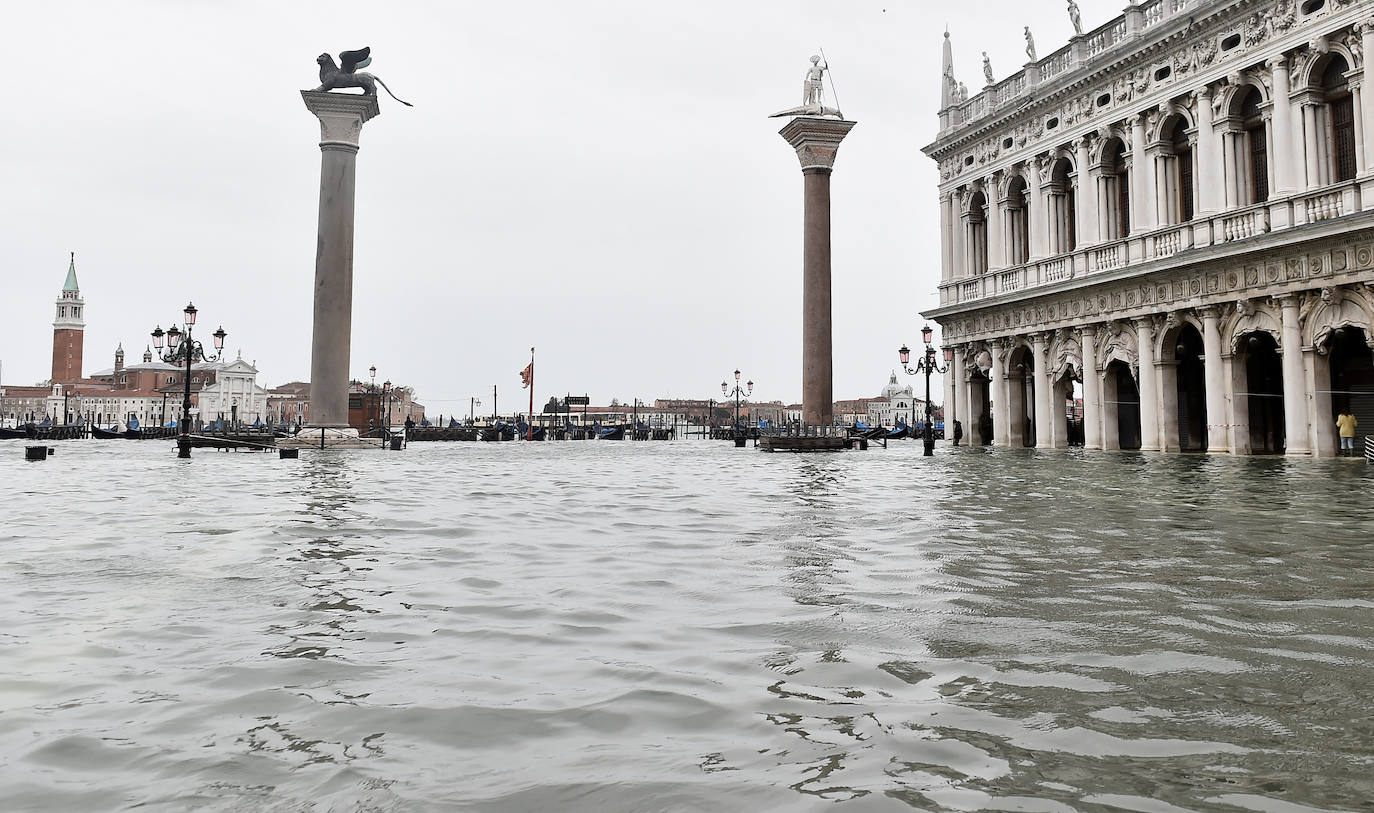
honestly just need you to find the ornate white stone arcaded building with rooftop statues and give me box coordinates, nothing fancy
[923,0,1374,456]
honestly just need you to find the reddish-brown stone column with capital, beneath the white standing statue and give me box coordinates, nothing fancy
[778,115,856,427]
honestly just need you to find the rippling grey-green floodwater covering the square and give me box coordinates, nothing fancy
[0,441,1374,813]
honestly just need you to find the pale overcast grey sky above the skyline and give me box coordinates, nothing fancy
[0,0,1093,413]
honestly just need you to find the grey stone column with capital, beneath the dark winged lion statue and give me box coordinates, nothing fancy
[301,91,381,434]
